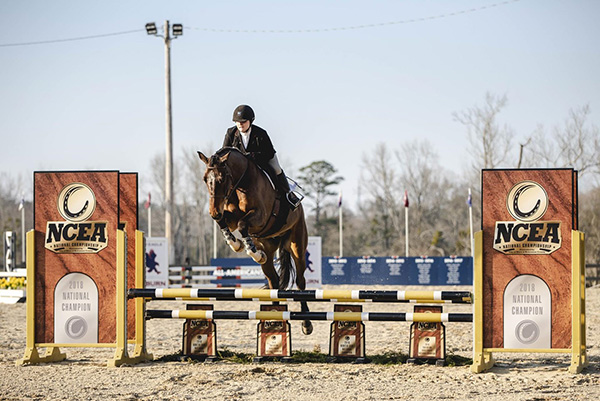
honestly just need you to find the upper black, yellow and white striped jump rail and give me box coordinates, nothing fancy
[128,288,472,304]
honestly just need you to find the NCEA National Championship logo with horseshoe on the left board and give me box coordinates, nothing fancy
[45,182,108,253]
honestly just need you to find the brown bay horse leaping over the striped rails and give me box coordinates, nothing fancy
[198,147,313,335]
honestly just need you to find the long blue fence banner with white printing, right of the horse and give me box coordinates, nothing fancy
[321,256,473,285]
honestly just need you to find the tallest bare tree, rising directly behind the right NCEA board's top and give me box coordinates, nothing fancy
[452,92,514,171]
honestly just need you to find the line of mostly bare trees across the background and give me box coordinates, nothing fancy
[0,93,600,265]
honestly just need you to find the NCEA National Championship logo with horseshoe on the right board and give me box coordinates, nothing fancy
[494,181,562,255]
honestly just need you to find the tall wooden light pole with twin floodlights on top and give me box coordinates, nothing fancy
[146,20,183,264]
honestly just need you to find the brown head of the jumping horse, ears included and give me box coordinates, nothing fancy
[198,152,233,221]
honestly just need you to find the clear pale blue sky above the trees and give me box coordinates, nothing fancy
[0,0,600,208]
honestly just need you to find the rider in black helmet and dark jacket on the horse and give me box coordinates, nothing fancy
[223,104,300,210]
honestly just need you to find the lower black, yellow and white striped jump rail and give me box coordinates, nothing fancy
[146,309,473,323]
